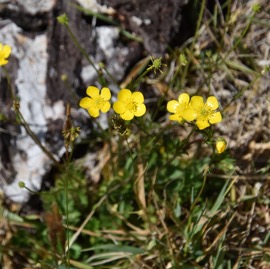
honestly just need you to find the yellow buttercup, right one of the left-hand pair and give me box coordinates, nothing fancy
[113,89,146,120]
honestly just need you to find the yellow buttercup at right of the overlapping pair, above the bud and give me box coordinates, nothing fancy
[190,96,222,130]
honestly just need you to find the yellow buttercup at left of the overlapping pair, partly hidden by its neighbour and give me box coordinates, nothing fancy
[167,93,197,123]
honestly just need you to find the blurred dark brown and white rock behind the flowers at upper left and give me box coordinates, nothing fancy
[0,0,196,202]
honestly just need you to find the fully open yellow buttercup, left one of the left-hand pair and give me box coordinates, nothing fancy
[79,86,111,118]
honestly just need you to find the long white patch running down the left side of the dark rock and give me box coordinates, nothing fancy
[0,23,64,202]
